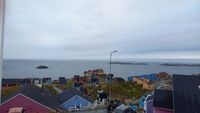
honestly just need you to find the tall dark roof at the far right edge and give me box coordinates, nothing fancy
[173,75,200,113]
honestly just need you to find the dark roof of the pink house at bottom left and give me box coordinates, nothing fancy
[2,85,59,110]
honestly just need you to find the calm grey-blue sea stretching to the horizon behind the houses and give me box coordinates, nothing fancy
[3,59,200,80]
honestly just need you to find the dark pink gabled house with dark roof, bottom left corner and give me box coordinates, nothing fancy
[0,85,60,113]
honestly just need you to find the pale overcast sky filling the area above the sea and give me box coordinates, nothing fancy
[4,0,200,59]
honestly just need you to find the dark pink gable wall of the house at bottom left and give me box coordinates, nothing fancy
[0,95,53,113]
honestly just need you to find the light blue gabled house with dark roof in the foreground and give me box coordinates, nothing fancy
[58,88,94,110]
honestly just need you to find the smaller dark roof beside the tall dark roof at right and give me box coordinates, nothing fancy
[153,89,173,110]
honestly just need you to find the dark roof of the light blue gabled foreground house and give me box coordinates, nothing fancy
[57,88,94,104]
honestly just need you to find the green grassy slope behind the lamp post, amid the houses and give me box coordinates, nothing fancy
[87,80,145,101]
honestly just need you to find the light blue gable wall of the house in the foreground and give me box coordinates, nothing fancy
[61,95,91,109]
